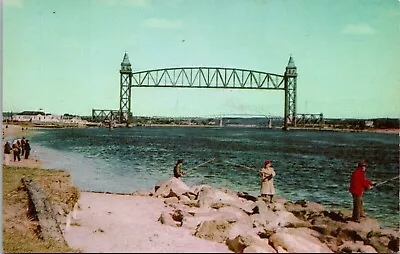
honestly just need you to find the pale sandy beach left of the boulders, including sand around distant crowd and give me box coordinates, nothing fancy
[3,125,231,253]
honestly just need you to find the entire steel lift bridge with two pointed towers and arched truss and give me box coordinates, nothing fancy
[92,52,324,130]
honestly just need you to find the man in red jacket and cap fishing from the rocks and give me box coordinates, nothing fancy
[349,161,376,222]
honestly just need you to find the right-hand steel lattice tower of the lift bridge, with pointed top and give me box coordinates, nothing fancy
[284,56,297,130]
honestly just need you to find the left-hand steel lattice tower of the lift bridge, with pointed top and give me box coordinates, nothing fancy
[119,52,132,126]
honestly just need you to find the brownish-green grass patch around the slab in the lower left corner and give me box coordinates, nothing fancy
[3,165,79,253]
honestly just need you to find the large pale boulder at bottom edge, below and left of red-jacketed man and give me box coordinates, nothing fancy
[269,228,333,253]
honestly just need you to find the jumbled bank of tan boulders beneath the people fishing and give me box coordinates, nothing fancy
[130,178,400,253]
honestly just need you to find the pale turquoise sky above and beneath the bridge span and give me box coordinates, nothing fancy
[2,0,400,118]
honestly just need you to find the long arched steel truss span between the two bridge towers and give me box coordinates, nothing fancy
[131,67,285,90]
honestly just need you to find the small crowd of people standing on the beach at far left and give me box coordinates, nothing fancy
[3,137,31,165]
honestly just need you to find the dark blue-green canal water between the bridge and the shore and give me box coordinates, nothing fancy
[31,127,399,228]
